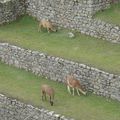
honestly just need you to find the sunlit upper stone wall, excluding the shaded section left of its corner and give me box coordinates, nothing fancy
[27,0,120,43]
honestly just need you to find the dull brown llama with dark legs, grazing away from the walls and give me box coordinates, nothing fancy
[41,84,54,106]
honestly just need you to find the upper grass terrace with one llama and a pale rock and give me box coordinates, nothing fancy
[0,16,120,74]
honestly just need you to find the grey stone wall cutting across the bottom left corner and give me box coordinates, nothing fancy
[0,94,74,120]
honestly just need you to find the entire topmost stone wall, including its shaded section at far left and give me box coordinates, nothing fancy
[0,0,120,43]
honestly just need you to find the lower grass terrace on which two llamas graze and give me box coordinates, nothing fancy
[0,62,120,120]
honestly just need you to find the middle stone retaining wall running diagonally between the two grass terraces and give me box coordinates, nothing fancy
[0,43,120,101]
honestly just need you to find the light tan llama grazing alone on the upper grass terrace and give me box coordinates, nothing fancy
[38,19,57,33]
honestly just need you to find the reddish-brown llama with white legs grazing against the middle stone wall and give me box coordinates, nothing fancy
[66,74,86,96]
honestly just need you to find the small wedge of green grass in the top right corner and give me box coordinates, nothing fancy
[95,3,120,26]
